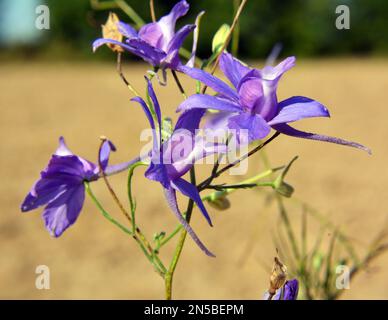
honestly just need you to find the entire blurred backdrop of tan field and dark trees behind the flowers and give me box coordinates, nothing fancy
[0,0,388,299]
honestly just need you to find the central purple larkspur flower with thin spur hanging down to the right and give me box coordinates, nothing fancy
[132,78,227,256]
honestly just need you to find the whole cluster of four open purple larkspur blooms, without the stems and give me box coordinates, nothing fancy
[21,0,369,262]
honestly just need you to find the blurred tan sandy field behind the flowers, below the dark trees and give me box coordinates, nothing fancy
[0,58,388,299]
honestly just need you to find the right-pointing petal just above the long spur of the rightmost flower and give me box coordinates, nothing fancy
[268,96,330,126]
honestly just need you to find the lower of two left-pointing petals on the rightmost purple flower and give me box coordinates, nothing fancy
[177,94,242,112]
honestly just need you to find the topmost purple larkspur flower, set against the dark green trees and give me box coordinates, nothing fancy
[93,0,195,70]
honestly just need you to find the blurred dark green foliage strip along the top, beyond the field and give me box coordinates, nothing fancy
[5,0,388,59]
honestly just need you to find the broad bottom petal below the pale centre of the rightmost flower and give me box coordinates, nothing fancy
[228,112,271,143]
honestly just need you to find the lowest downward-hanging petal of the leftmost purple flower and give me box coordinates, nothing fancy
[43,184,85,237]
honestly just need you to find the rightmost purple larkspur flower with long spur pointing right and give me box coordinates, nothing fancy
[177,53,370,152]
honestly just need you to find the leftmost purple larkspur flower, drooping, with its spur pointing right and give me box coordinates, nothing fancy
[21,137,139,237]
